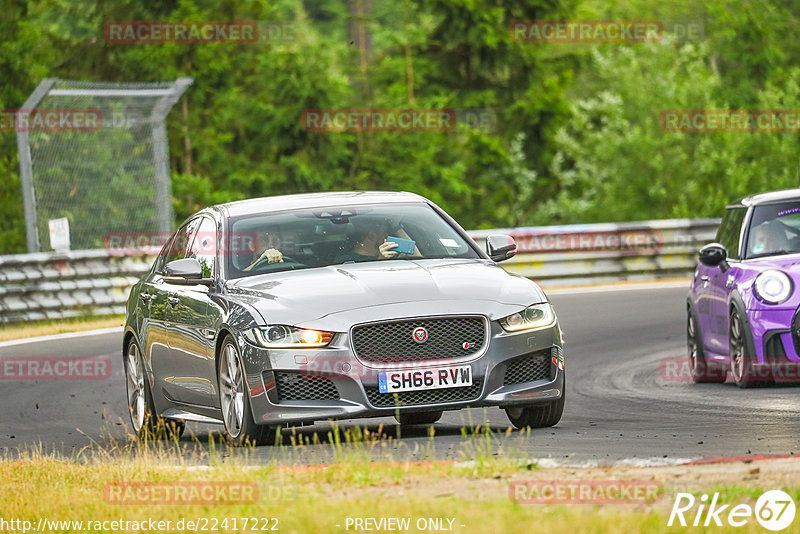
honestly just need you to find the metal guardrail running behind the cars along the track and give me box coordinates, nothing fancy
[0,219,719,323]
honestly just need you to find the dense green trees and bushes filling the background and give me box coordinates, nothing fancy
[0,0,800,253]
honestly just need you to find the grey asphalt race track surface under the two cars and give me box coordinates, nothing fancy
[0,285,800,465]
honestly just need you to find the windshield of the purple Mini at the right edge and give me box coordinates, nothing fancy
[746,200,800,258]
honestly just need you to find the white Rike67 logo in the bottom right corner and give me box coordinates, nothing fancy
[667,490,796,532]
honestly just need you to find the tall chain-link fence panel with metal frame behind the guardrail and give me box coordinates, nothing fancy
[16,78,192,252]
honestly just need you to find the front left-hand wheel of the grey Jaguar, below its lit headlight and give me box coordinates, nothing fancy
[217,335,276,446]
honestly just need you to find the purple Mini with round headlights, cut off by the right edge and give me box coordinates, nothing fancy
[686,189,800,387]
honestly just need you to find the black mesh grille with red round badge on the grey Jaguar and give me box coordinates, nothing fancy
[353,317,486,363]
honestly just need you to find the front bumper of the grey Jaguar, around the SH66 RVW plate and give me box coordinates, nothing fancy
[240,322,564,424]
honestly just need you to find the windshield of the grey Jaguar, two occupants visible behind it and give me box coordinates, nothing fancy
[222,204,480,278]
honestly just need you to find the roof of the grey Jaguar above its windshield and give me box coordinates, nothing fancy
[211,191,427,217]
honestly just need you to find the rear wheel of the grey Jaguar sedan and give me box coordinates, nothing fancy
[125,339,186,440]
